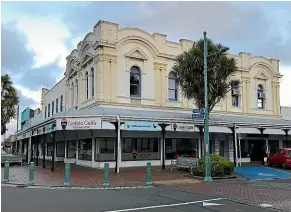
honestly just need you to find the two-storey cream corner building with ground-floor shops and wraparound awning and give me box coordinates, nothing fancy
[16,21,291,170]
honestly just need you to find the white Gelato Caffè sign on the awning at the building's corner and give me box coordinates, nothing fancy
[57,117,101,130]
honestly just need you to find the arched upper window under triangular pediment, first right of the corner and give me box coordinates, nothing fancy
[130,66,141,97]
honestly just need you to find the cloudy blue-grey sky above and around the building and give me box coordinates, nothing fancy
[1,2,291,137]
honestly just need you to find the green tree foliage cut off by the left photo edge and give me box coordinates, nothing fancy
[1,74,19,135]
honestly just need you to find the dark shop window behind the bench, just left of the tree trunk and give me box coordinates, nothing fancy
[166,138,198,159]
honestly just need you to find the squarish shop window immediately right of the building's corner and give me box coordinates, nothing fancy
[95,138,115,161]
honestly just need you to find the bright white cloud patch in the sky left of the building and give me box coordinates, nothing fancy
[17,16,71,68]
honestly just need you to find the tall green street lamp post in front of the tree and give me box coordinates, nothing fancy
[203,32,229,182]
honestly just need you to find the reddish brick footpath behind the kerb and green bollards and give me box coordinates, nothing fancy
[1,164,189,186]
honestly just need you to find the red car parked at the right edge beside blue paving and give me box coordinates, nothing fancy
[267,148,291,169]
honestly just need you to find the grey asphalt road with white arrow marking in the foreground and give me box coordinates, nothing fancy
[1,186,268,212]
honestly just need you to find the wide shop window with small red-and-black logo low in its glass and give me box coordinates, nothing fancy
[121,138,160,161]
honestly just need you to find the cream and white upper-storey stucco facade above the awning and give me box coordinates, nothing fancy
[60,21,281,117]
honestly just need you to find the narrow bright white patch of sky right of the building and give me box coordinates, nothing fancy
[280,66,291,107]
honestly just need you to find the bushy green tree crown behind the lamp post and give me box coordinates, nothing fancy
[173,39,239,112]
